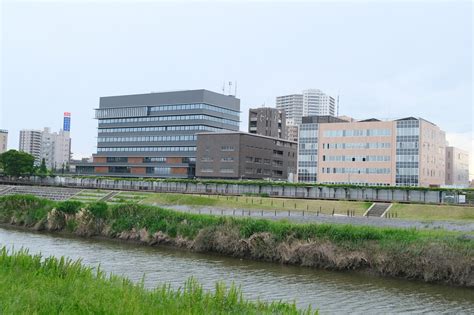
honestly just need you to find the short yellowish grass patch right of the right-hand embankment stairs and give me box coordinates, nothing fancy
[390,203,474,222]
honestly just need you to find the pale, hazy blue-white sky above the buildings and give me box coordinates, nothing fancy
[0,0,474,178]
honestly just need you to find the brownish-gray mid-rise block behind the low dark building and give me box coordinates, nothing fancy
[249,107,286,139]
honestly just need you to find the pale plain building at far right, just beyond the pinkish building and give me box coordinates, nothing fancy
[445,146,469,188]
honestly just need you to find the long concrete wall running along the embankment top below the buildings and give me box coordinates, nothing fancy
[12,176,468,204]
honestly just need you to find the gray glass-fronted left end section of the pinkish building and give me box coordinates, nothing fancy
[298,116,347,183]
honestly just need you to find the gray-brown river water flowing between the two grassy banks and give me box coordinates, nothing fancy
[0,228,474,314]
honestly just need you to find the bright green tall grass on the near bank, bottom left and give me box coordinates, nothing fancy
[0,248,311,314]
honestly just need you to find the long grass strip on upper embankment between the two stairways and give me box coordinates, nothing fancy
[142,193,372,216]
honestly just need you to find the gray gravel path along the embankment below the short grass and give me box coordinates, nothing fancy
[154,203,474,232]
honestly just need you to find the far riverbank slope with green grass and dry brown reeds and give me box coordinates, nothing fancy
[0,196,474,287]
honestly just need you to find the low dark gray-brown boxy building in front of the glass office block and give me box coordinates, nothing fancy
[196,132,297,181]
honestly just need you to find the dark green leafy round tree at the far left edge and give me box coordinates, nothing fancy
[0,150,35,176]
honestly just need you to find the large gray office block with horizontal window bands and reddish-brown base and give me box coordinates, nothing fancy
[76,90,240,178]
